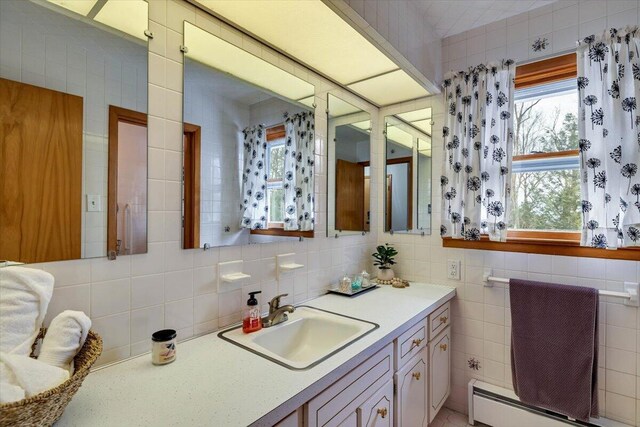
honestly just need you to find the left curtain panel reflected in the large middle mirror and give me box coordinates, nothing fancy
[240,125,269,229]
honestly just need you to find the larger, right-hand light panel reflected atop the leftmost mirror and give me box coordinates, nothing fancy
[94,0,149,42]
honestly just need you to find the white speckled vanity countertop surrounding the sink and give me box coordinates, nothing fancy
[56,283,455,427]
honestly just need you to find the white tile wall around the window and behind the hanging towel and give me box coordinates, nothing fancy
[396,1,640,425]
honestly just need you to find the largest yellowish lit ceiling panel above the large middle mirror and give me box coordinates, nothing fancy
[197,0,398,85]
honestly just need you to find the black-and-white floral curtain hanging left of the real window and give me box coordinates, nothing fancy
[440,60,515,241]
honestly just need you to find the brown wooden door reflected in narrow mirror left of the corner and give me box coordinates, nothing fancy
[336,160,364,231]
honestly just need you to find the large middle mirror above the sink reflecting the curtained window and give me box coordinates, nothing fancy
[183,22,315,249]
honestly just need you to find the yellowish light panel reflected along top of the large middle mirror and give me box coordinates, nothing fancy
[184,22,315,105]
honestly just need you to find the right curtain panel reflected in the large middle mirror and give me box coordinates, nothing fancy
[283,111,315,231]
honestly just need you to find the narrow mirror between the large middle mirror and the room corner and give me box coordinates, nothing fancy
[327,93,371,236]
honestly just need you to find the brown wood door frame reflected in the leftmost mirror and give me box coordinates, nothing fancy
[107,105,147,258]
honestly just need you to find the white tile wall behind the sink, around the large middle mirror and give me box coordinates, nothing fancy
[22,0,377,363]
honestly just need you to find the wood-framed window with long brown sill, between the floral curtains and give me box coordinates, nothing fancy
[443,54,639,260]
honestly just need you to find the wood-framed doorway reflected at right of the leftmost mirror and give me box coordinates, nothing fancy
[107,106,147,256]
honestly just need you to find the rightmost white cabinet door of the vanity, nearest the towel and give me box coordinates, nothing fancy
[429,327,451,422]
